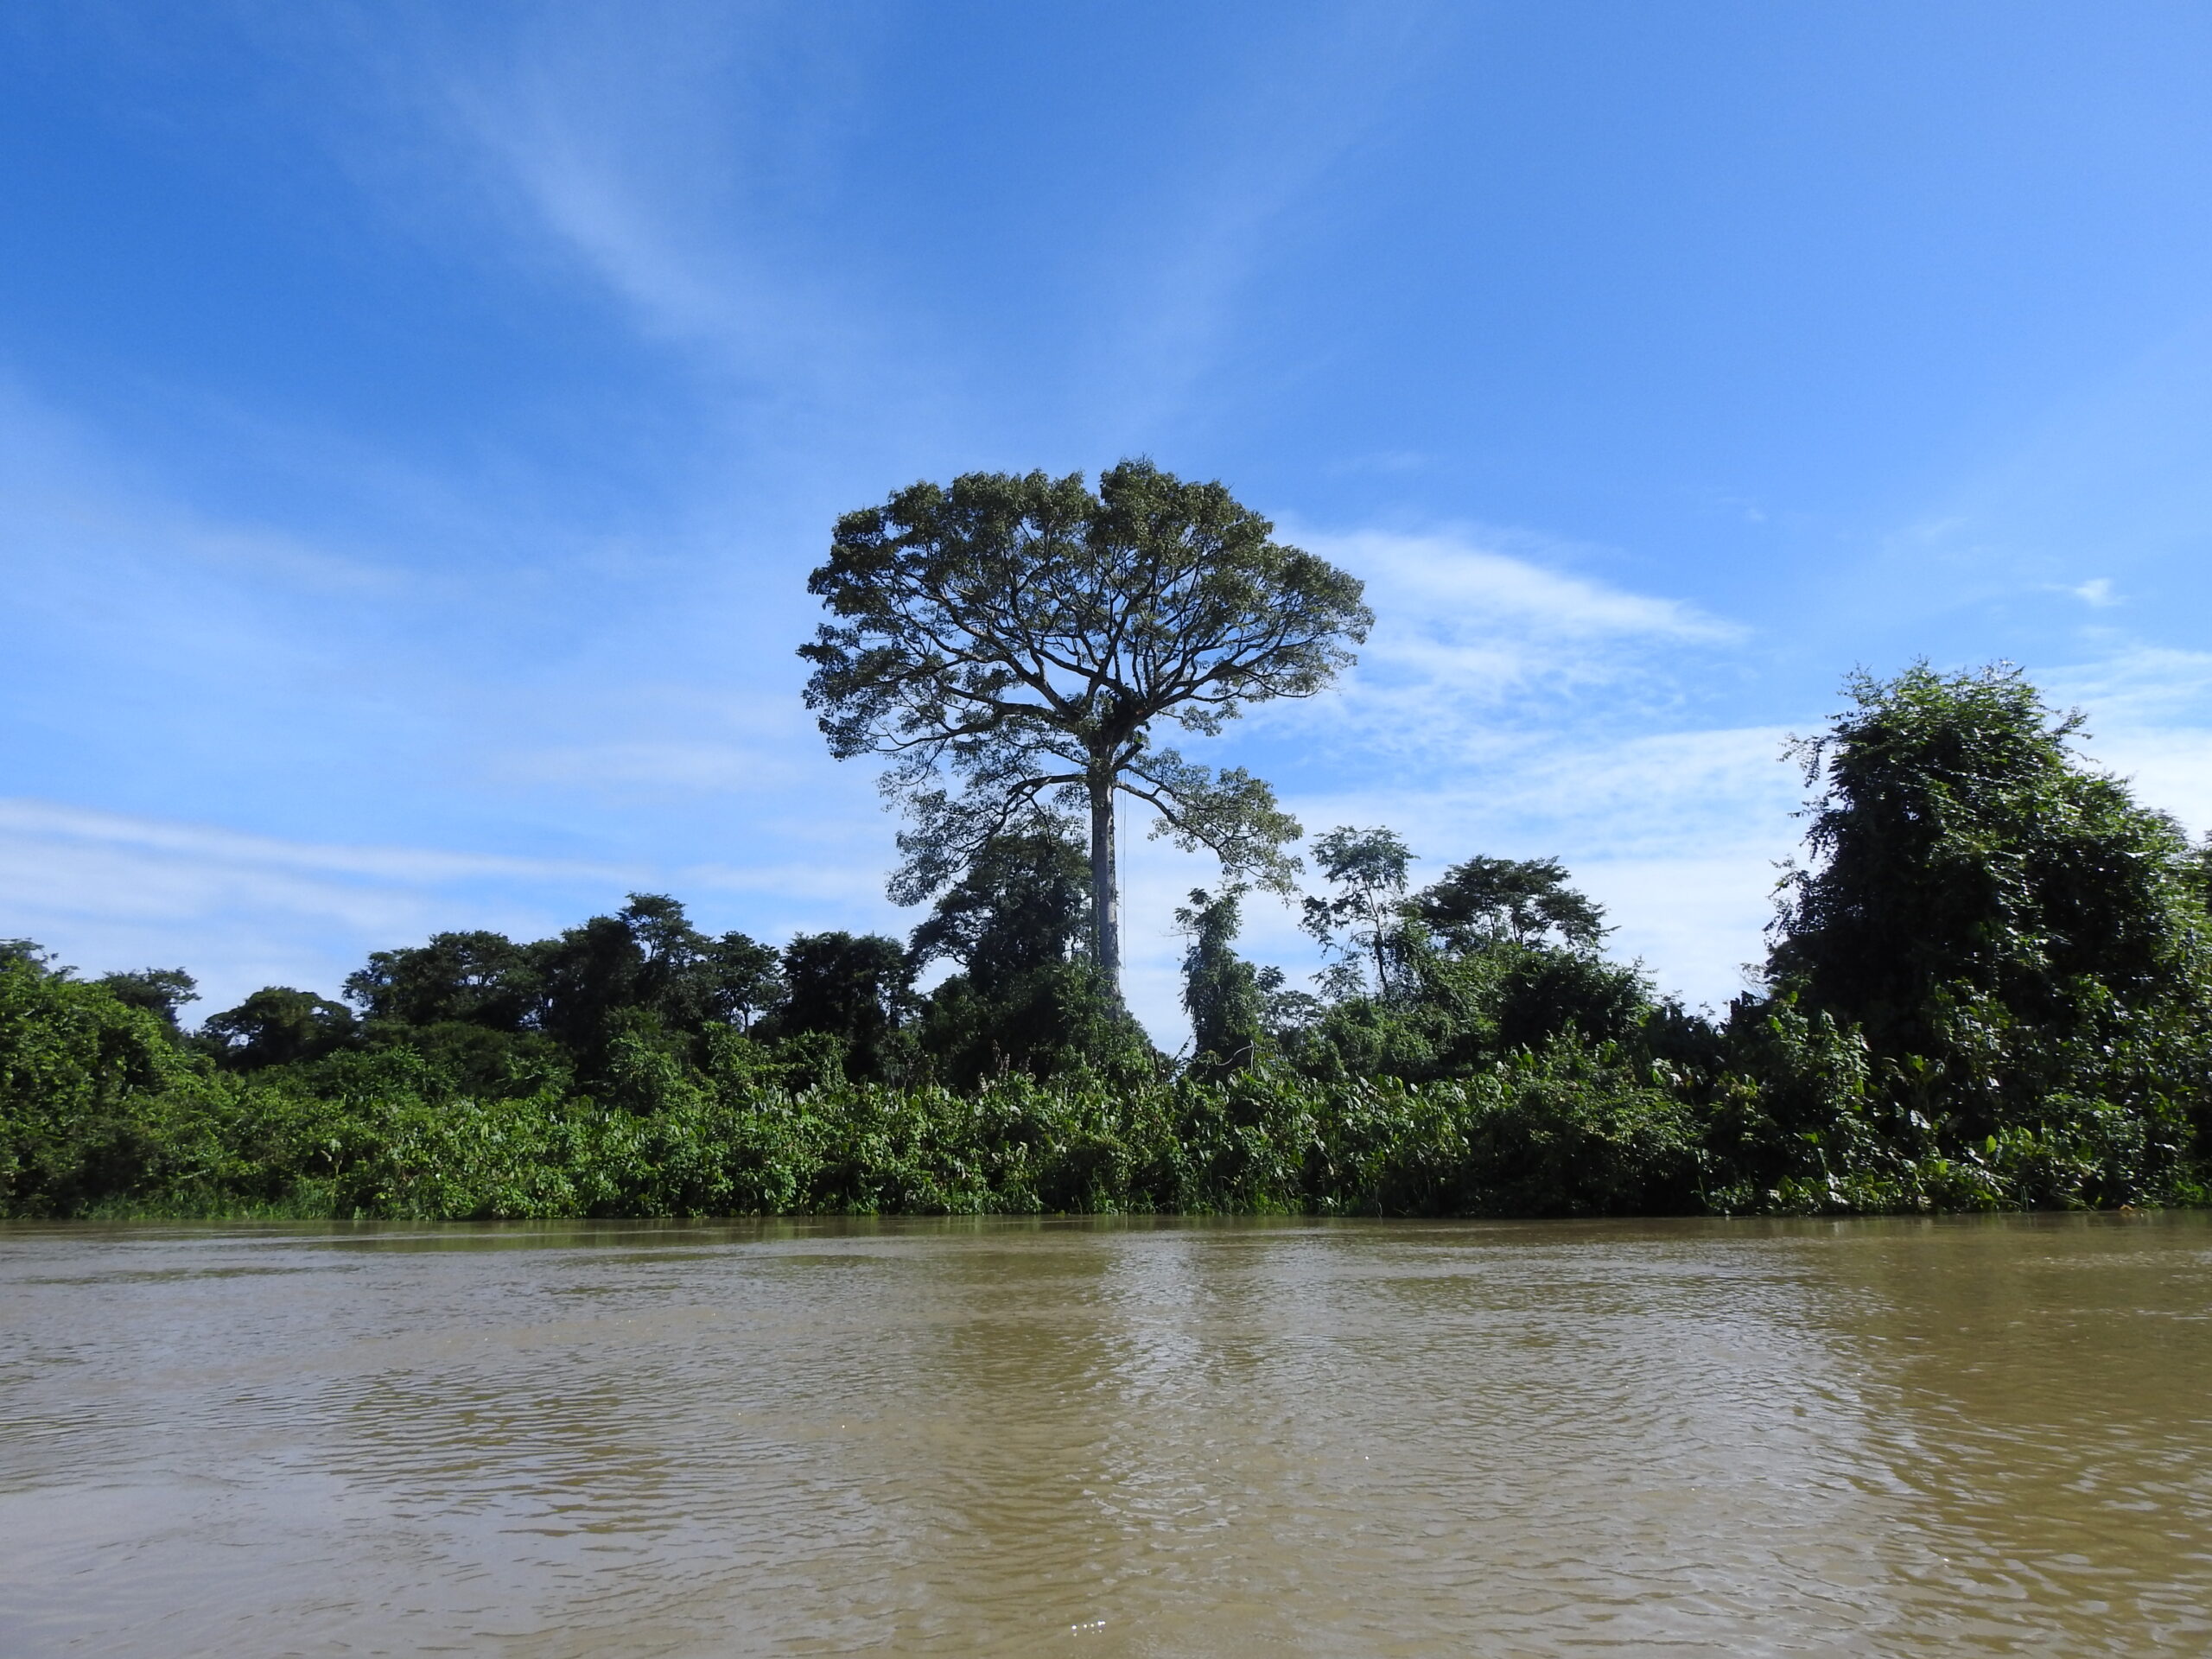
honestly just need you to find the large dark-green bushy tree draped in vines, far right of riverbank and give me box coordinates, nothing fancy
[1770,666,2212,1139]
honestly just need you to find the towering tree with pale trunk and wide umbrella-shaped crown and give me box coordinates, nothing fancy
[798,460,1374,993]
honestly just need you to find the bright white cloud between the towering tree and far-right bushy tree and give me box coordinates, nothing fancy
[1106,529,1802,1031]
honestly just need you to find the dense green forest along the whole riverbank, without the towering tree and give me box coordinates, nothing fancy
[0,666,2212,1217]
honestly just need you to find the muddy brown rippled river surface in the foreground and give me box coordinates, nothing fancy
[0,1214,2212,1659]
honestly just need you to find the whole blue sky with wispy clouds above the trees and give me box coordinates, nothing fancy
[0,0,2212,1038]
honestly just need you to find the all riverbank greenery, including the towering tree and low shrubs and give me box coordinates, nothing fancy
[0,462,2212,1214]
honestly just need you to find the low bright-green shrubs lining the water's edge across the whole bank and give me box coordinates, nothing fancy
[0,967,2203,1219]
